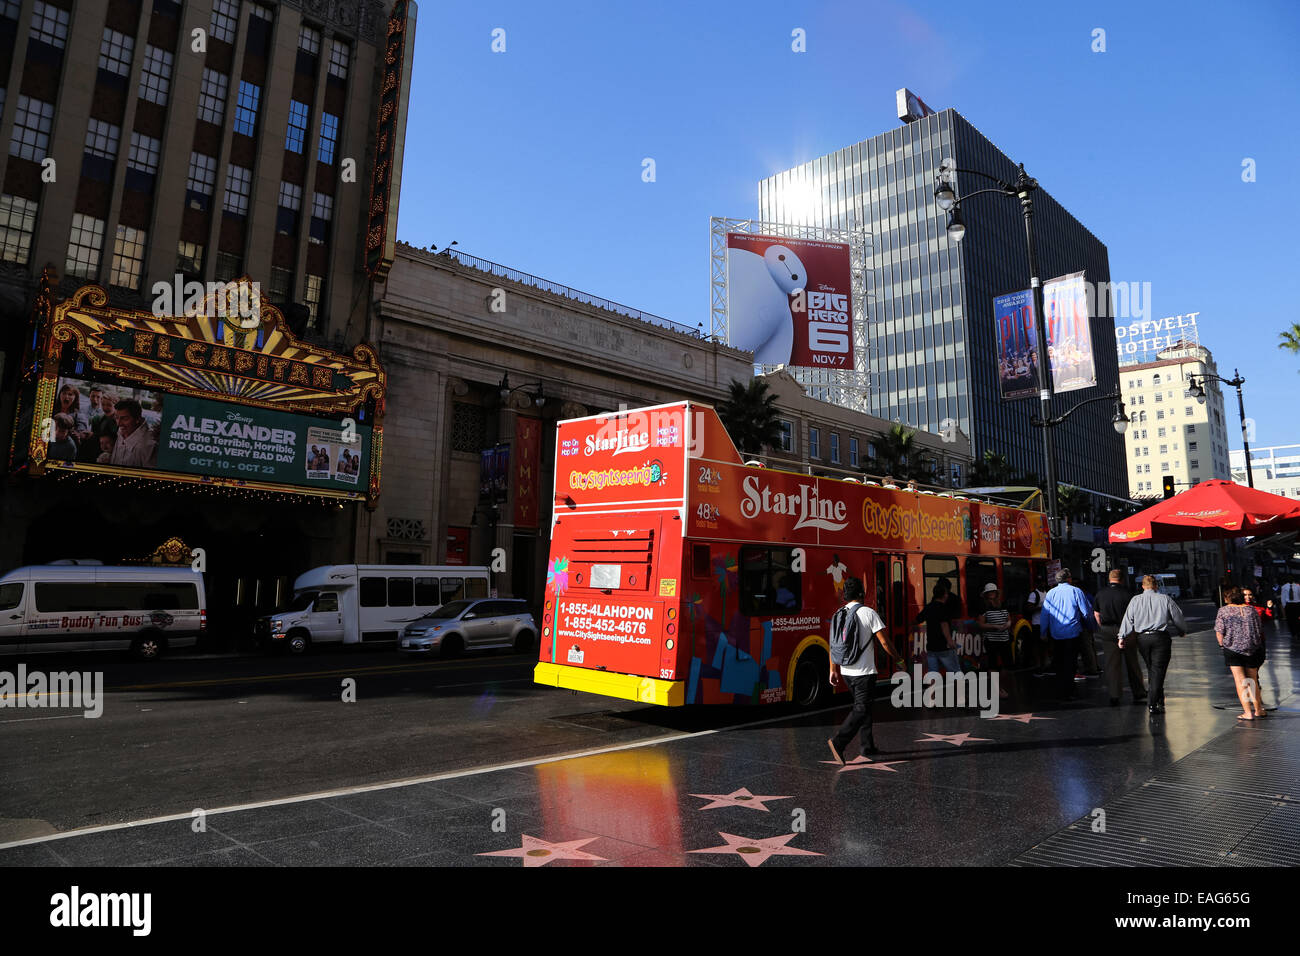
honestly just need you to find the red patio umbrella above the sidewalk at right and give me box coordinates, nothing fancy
[1109,480,1300,544]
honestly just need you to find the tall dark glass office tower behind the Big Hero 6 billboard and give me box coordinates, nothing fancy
[759,109,1128,497]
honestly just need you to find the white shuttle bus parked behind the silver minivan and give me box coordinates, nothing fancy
[257,564,489,654]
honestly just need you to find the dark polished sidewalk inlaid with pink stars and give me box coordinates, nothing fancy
[0,613,1300,866]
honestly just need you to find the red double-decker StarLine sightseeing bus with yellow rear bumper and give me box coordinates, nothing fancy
[534,402,1049,706]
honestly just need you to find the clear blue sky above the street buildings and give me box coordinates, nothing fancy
[398,0,1300,447]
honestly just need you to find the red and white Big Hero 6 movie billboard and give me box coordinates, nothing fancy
[727,233,854,369]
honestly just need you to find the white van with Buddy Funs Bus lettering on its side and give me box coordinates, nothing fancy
[0,563,208,661]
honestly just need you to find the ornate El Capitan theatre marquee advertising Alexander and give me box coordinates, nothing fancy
[10,278,386,509]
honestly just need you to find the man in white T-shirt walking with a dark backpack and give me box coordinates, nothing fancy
[827,578,897,763]
